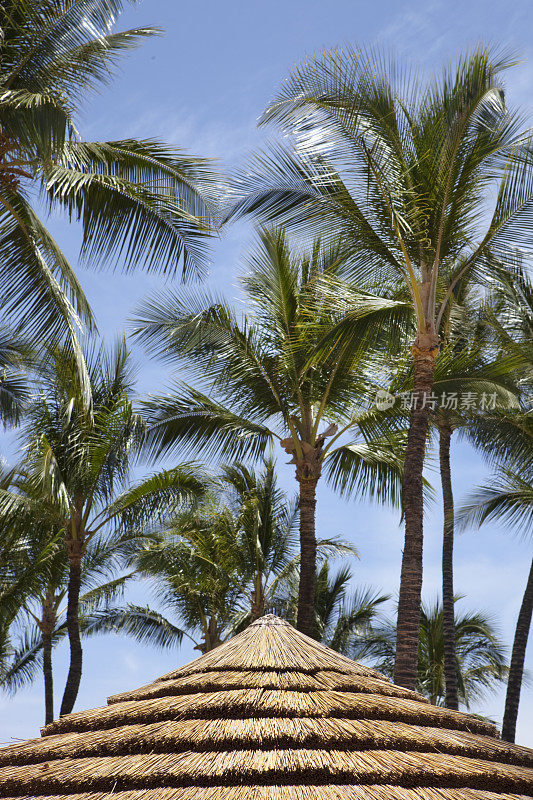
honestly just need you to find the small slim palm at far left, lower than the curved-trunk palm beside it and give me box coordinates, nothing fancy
[0,524,137,725]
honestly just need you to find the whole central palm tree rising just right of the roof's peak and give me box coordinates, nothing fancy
[132,231,400,633]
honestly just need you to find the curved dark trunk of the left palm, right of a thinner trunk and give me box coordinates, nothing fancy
[60,539,83,717]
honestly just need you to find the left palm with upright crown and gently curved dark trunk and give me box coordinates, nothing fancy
[0,344,204,715]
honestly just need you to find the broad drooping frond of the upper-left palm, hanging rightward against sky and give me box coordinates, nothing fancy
[43,140,215,277]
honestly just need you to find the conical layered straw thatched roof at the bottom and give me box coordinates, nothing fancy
[0,616,533,800]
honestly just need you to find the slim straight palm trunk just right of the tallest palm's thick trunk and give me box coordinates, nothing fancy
[439,423,459,711]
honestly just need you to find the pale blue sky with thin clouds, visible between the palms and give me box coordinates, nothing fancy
[0,0,533,746]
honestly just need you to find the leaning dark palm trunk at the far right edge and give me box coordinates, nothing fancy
[502,561,533,742]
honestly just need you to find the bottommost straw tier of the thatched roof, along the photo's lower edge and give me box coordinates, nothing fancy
[0,750,533,793]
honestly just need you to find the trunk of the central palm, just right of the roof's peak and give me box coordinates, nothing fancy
[296,477,317,636]
